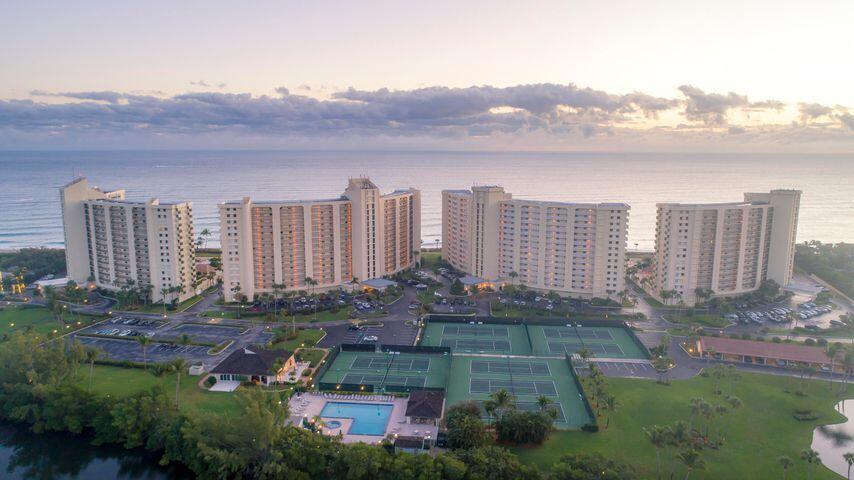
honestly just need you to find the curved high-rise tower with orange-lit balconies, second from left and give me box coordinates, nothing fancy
[219,178,421,301]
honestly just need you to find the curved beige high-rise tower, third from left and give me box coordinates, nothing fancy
[442,186,629,297]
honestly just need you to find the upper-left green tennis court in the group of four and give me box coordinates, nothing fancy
[421,321,531,355]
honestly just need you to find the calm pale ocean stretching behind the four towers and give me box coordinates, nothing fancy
[0,151,854,250]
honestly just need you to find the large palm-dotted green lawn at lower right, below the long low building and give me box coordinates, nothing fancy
[513,373,854,479]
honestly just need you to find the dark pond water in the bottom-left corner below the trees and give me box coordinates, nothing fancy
[0,422,193,480]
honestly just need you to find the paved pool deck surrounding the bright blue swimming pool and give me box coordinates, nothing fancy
[289,392,439,443]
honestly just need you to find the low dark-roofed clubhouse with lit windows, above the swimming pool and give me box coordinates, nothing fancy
[211,347,296,385]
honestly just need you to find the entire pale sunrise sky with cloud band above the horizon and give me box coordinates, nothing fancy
[0,0,854,152]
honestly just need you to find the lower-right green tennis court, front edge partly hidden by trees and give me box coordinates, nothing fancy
[447,355,592,428]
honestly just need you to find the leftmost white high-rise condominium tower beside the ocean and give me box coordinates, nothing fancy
[59,178,196,301]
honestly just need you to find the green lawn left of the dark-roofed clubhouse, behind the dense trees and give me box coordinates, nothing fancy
[78,365,243,414]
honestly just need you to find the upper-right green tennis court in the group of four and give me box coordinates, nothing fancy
[527,325,647,359]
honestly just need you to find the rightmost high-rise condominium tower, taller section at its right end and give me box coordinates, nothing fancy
[652,190,801,305]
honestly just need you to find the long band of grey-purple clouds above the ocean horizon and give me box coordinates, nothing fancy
[0,81,854,148]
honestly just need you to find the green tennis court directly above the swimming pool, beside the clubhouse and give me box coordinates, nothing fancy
[318,351,451,392]
